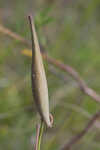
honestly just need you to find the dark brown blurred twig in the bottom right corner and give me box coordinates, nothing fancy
[61,111,100,150]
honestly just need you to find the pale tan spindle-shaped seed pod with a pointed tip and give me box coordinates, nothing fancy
[29,16,52,127]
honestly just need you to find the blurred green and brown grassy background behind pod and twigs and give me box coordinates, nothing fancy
[0,0,100,150]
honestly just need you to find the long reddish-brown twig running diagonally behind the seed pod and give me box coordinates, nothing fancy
[0,25,100,102]
